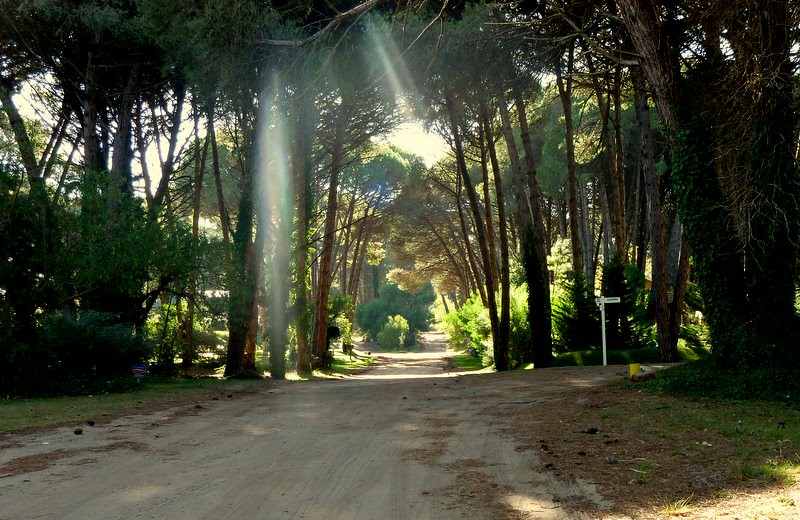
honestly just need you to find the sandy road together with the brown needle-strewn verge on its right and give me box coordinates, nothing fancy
[0,334,800,520]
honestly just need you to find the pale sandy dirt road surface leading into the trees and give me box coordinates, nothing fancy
[0,334,614,520]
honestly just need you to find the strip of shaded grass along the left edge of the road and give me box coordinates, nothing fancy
[0,377,246,433]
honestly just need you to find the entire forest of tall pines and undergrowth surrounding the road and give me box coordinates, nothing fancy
[0,0,800,395]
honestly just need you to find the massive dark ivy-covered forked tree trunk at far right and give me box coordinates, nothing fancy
[617,0,800,368]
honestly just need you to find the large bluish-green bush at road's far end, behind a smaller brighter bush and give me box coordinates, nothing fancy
[356,282,436,344]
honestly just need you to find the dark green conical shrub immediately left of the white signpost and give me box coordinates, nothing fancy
[552,271,602,352]
